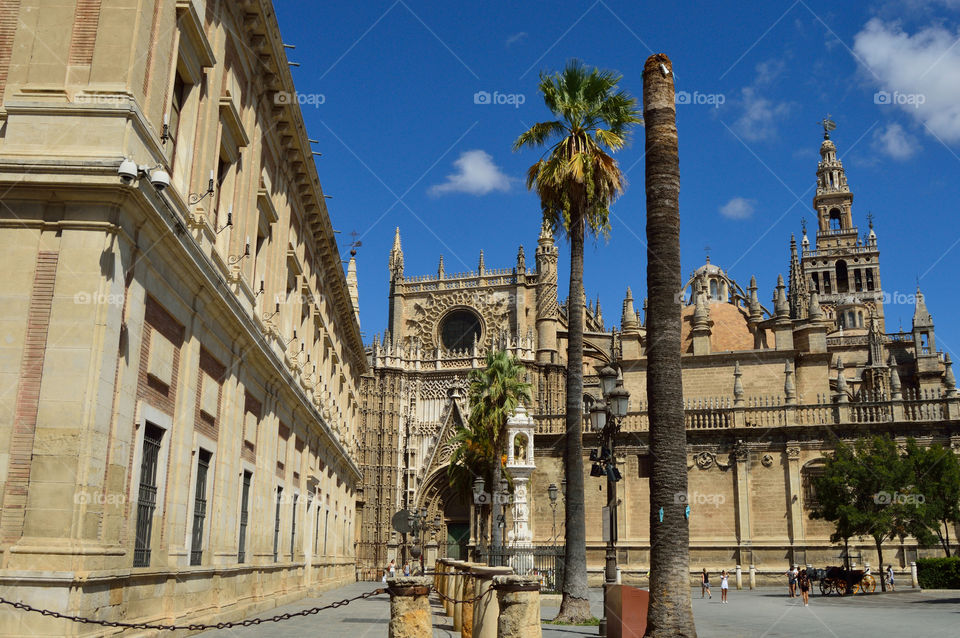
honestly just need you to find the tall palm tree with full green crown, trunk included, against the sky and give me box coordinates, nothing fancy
[513,60,641,622]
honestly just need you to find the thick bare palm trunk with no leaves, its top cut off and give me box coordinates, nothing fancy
[643,53,697,638]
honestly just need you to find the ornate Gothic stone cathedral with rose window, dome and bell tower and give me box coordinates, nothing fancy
[359,127,960,577]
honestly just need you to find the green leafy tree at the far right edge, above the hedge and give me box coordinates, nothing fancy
[904,439,960,557]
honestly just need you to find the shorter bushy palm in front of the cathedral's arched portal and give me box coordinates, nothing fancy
[448,350,530,552]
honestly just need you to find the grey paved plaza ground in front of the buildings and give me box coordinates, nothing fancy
[202,583,960,638]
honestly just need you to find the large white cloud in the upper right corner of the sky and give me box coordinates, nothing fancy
[853,18,960,143]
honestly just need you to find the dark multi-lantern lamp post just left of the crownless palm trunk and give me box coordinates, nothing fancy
[590,366,630,636]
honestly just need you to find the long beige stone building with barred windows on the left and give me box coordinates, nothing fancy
[0,0,367,636]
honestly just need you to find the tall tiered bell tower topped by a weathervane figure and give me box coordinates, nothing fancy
[791,118,884,333]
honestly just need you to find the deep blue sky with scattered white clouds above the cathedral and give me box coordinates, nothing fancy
[276,0,960,359]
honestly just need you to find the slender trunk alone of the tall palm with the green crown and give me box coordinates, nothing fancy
[557,208,591,622]
